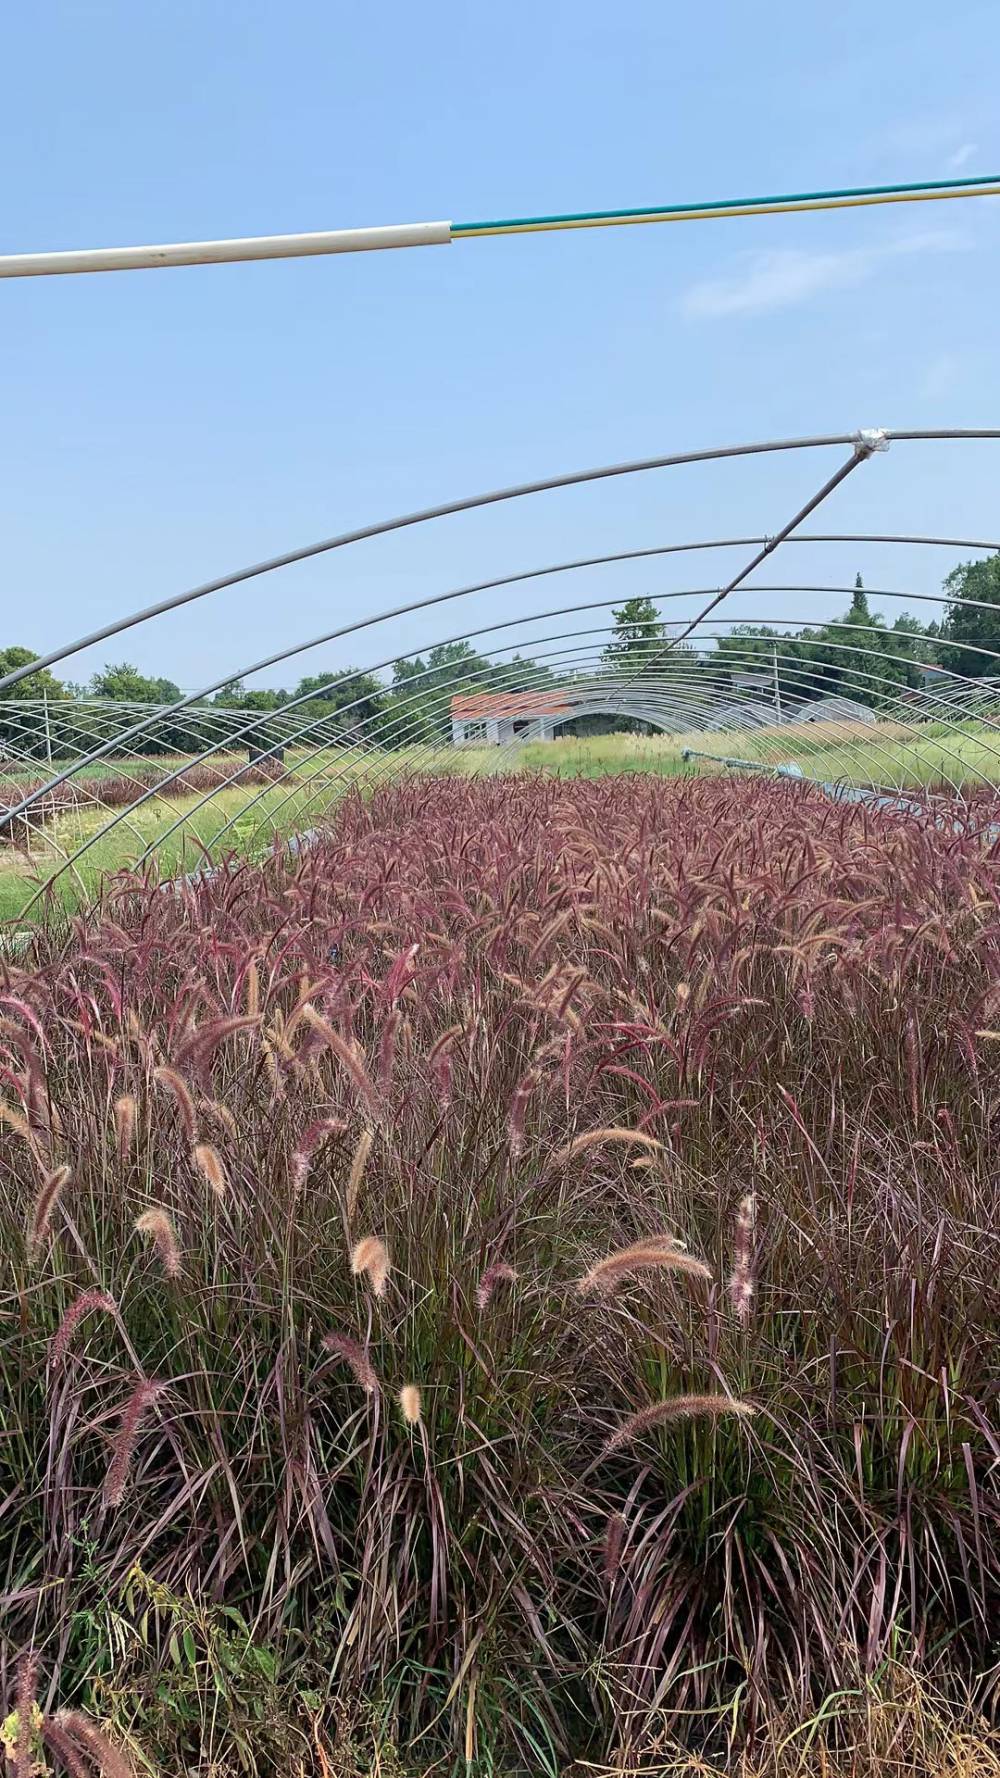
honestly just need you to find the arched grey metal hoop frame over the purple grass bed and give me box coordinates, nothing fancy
[0,428,1000,907]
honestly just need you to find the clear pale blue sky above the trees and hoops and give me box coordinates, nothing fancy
[0,0,1000,688]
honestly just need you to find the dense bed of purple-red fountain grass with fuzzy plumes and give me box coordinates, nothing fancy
[0,773,1000,1778]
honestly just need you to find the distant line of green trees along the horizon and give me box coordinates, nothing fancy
[0,555,1000,757]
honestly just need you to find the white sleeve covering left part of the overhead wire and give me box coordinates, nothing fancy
[0,222,452,277]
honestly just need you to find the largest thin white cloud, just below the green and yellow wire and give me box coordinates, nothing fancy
[681,231,968,320]
